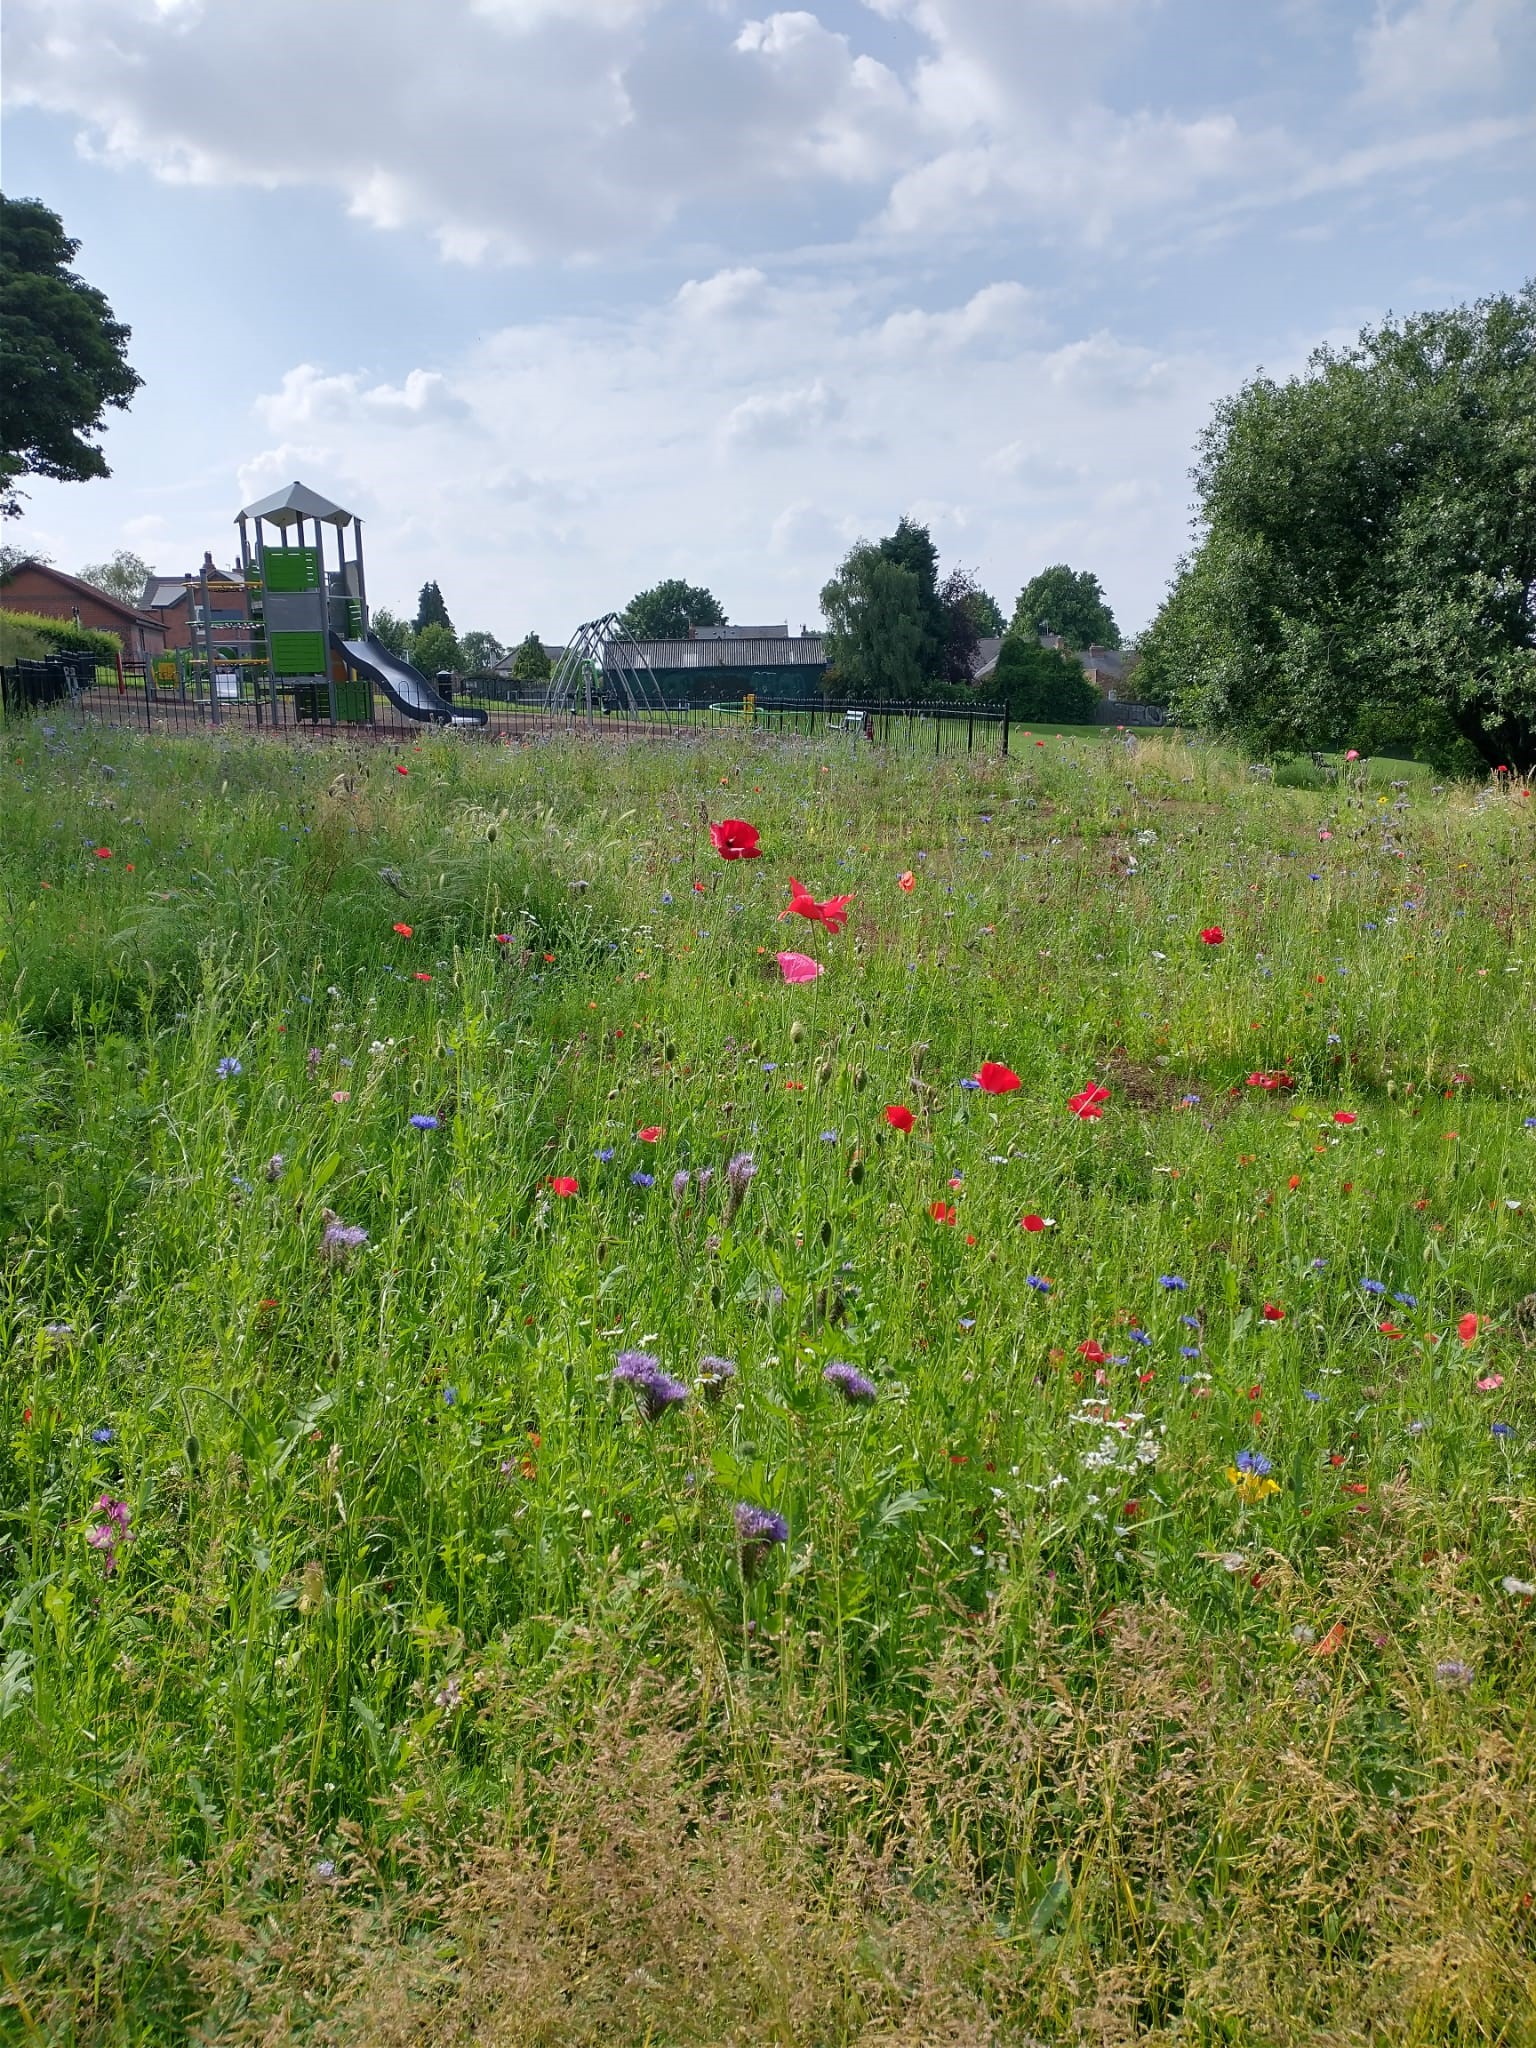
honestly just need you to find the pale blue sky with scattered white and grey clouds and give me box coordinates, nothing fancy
[4,0,1536,641]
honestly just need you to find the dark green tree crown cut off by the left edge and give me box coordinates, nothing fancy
[0,193,143,518]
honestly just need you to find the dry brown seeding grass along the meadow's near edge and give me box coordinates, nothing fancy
[12,1593,1536,2048]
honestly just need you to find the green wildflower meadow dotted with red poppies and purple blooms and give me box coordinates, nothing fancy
[0,725,1536,2048]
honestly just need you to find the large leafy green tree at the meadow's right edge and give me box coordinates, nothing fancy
[1141,283,1536,768]
